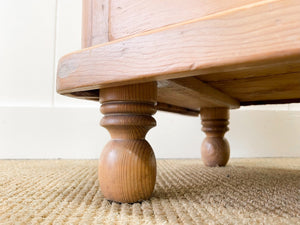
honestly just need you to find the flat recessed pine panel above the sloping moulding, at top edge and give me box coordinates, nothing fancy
[110,0,261,40]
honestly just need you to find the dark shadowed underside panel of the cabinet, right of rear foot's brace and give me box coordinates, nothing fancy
[209,72,300,105]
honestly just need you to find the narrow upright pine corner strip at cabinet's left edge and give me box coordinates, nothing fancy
[81,0,109,48]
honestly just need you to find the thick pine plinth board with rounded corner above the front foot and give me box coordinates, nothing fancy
[57,0,300,96]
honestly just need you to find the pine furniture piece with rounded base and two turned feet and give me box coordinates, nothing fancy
[57,0,300,202]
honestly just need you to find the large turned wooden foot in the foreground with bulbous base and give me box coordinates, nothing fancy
[98,82,157,203]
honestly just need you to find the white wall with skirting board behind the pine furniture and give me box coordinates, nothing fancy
[0,0,300,158]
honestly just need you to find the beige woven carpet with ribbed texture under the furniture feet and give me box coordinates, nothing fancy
[0,158,300,225]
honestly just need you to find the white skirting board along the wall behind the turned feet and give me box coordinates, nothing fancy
[0,107,300,159]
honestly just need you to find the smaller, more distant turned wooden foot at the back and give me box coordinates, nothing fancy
[200,108,230,166]
